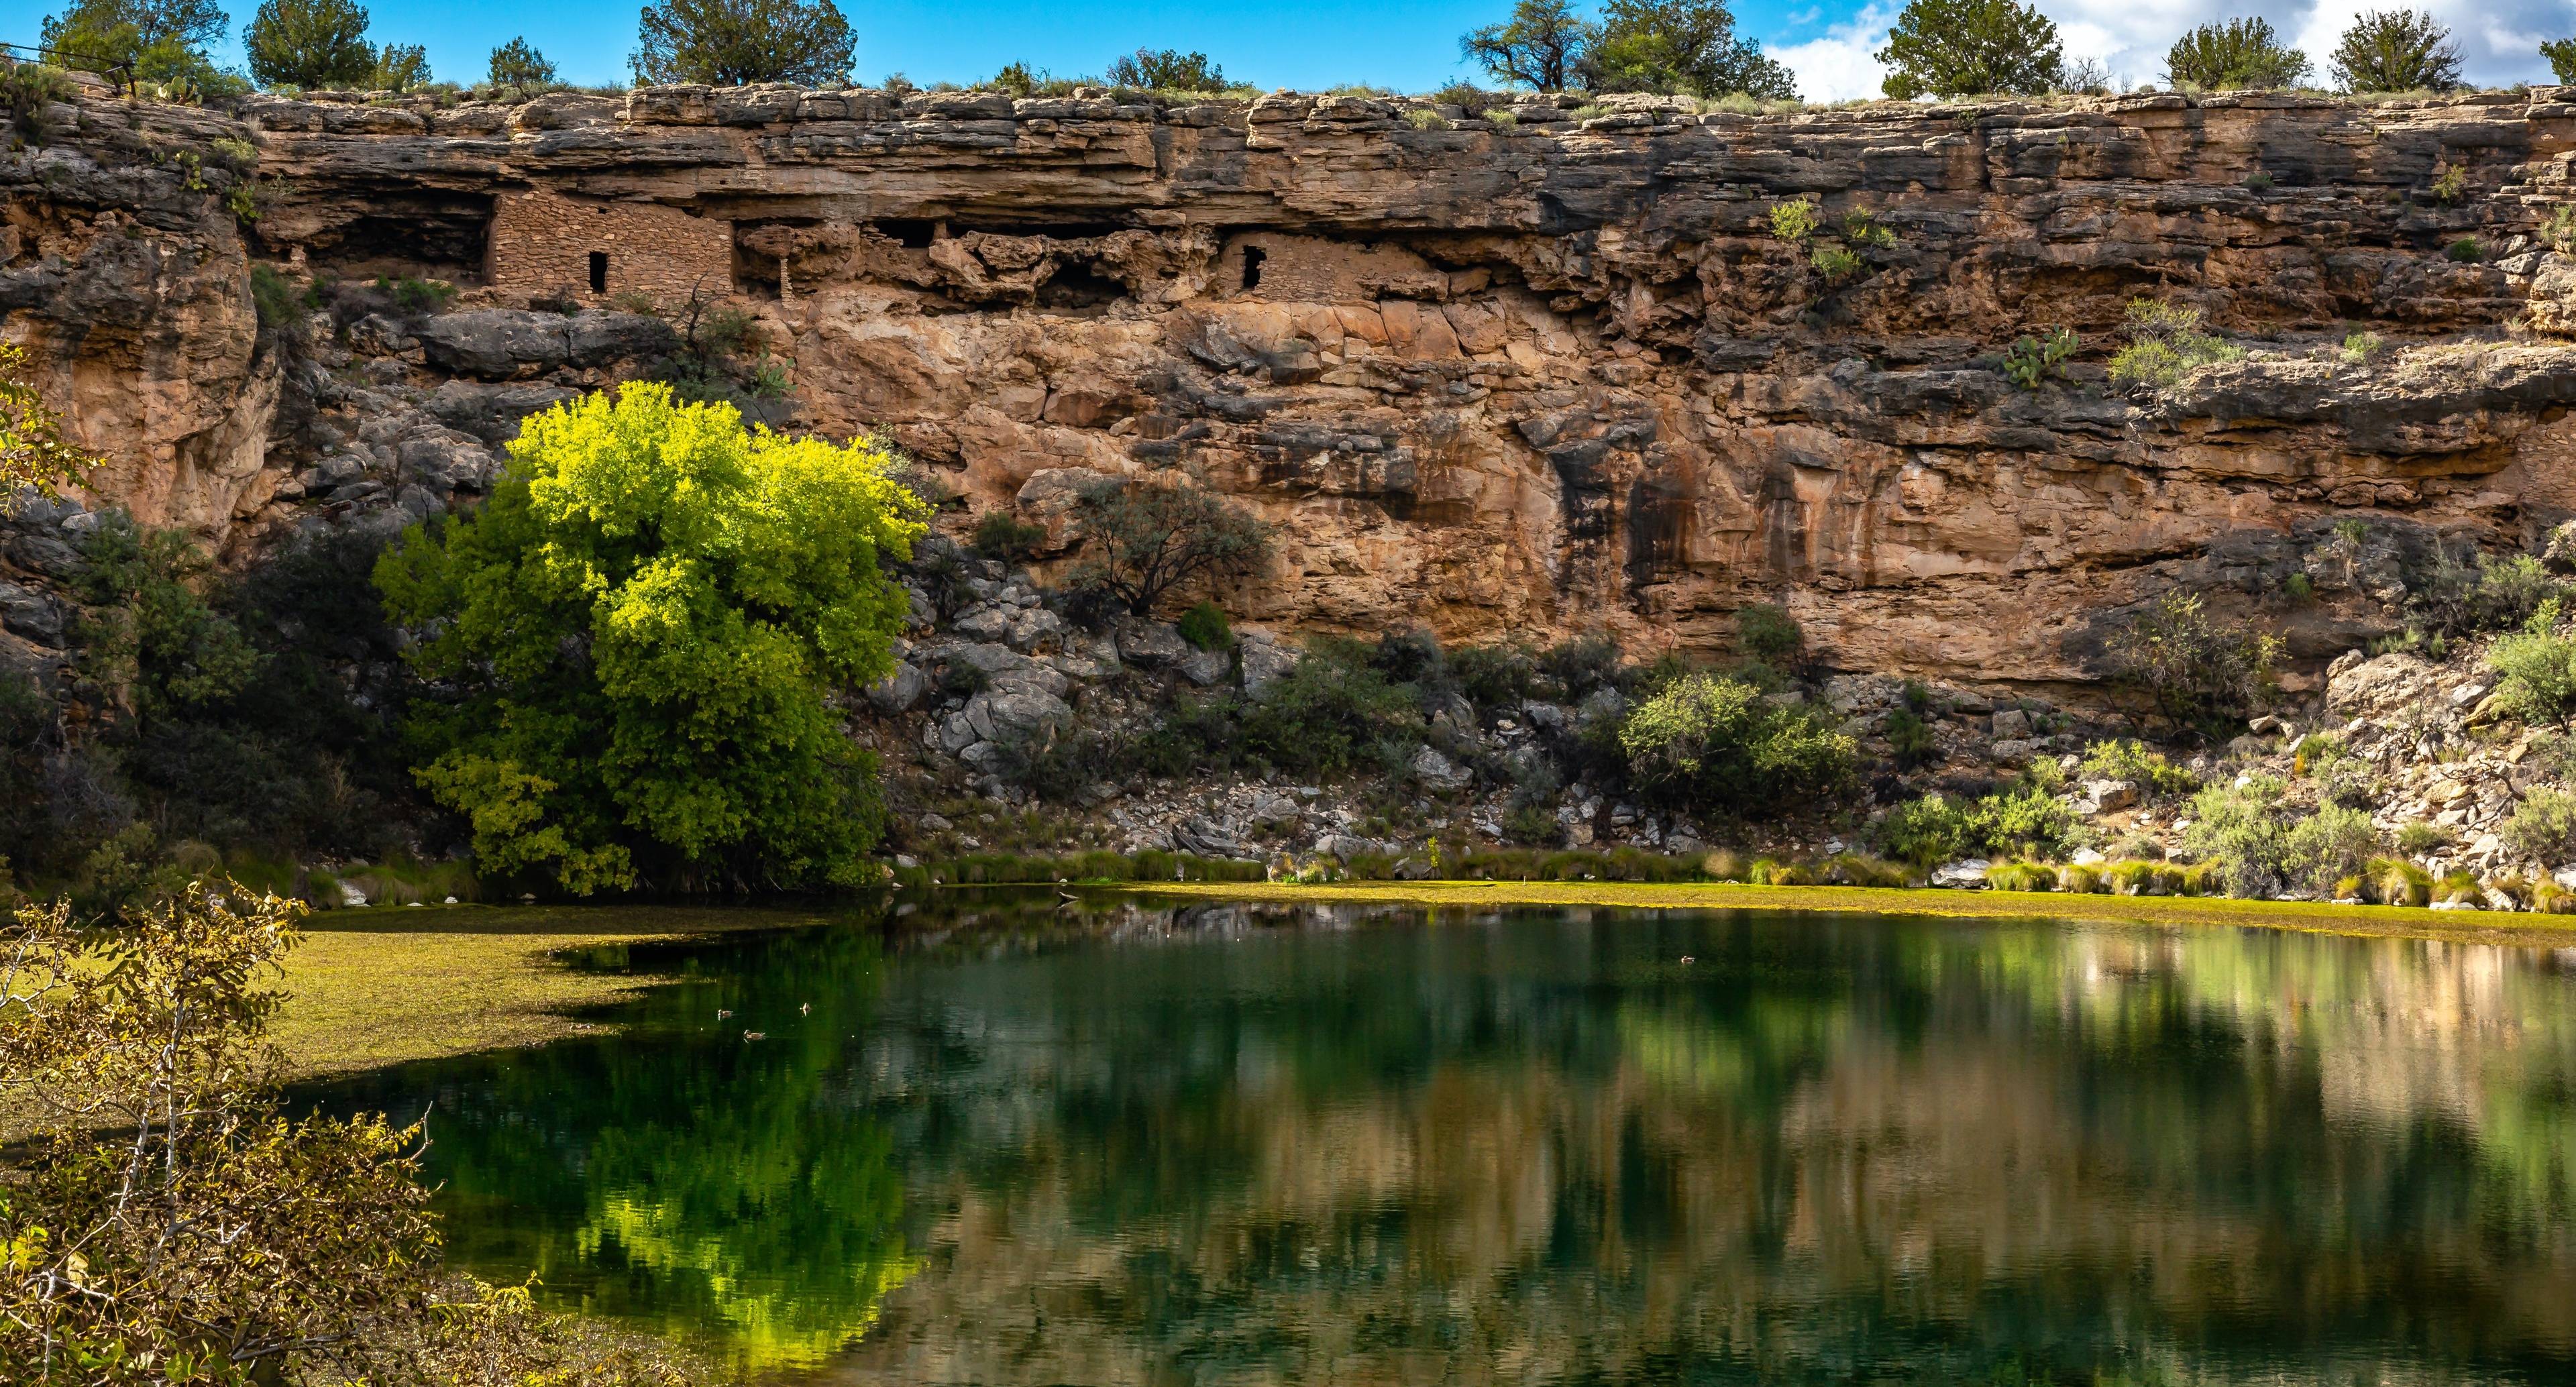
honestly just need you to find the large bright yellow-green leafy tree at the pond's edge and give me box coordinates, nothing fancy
[376,384,925,893]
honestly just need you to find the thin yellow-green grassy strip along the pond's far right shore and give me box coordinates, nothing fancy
[1126,880,2576,944]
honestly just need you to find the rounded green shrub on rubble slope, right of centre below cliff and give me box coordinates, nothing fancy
[1618,674,1860,813]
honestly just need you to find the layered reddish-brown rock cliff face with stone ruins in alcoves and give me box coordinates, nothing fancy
[15,87,2576,692]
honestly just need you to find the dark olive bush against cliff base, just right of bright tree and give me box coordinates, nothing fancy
[1074,476,1270,618]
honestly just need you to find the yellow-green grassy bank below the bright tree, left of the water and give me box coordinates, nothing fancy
[273,906,822,1078]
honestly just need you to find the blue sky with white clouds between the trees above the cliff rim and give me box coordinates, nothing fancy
[166,0,2576,101]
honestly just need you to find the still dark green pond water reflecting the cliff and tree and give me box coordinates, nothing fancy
[311,893,2576,1384]
